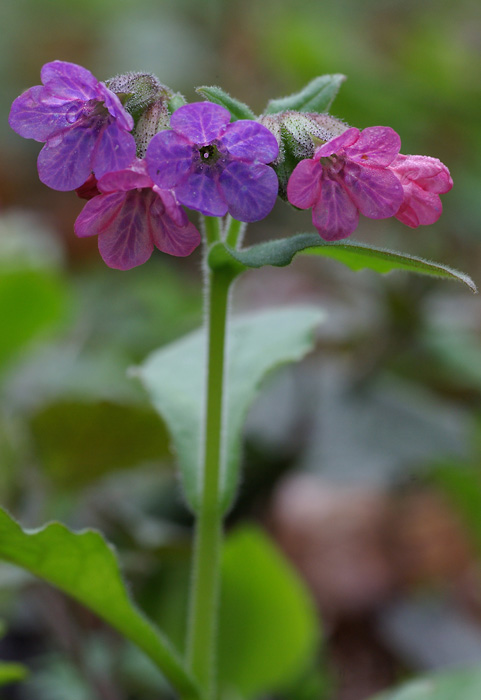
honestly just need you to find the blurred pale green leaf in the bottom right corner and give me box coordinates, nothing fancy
[372,668,481,700]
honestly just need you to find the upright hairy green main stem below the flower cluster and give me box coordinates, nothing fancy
[187,237,232,700]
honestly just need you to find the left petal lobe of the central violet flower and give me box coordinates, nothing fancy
[145,131,193,190]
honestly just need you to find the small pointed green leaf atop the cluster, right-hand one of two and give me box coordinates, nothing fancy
[265,73,346,114]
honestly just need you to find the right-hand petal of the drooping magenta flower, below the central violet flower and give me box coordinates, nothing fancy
[149,193,201,257]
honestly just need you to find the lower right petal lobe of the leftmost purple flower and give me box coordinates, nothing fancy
[91,121,136,179]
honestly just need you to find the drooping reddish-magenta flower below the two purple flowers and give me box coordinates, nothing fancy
[75,160,200,270]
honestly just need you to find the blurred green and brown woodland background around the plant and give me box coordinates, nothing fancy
[0,0,481,700]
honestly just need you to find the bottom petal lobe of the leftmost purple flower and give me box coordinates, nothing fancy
[37,128,97,192]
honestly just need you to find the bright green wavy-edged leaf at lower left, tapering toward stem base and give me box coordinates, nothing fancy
[0,509,199,700]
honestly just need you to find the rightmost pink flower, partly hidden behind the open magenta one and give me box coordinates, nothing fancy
[389,154,453,228]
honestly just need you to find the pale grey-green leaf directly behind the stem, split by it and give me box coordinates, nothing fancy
[133,307,322,510]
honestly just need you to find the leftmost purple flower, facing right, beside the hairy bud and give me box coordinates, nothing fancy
[9,61,136,191]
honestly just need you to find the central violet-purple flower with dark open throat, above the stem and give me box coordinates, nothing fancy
[146,102,279,221]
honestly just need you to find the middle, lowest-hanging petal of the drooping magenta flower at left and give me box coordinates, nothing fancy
[95,190,154,270]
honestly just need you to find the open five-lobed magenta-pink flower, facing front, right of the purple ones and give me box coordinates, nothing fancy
[287,126,403,241]
